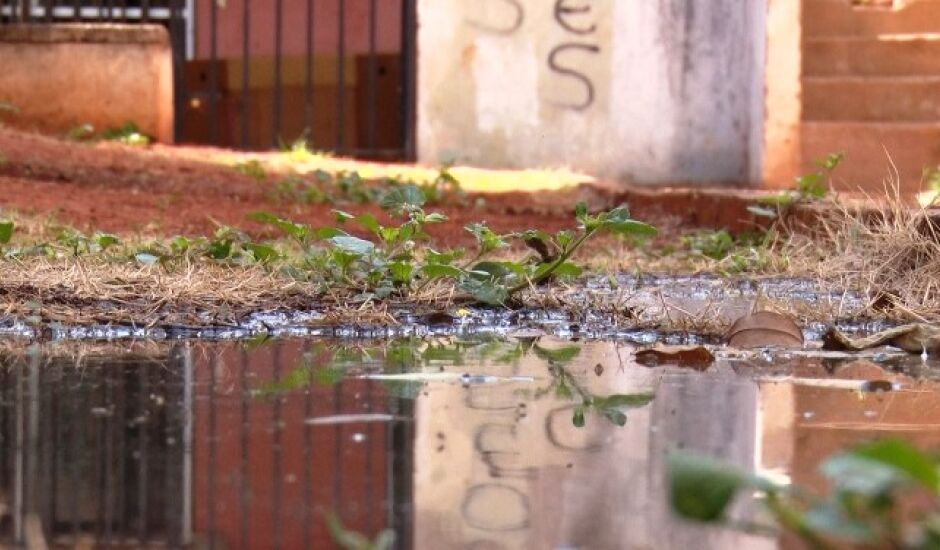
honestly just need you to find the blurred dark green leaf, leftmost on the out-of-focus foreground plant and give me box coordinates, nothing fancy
[666,451,751,523]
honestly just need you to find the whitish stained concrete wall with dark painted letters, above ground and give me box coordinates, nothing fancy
[418,0,766,183]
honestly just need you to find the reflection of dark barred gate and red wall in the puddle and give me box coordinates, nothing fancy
[0,342,414,548]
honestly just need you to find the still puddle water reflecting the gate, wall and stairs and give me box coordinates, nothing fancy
[0,337,940,550]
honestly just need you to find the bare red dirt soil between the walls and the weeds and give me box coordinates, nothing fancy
[0,127,788,246]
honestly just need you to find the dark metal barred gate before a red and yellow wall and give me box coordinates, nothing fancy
[0,0,416,159]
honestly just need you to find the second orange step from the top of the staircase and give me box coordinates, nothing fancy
[803,33,940,76]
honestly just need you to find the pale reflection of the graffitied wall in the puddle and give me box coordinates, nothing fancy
[414,343,773,549]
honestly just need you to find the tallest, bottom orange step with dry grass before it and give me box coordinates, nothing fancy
[800,122,940,193]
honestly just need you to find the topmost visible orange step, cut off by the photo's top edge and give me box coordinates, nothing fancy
[802,0,940,38]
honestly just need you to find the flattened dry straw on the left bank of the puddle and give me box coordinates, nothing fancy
[0,257,312,326]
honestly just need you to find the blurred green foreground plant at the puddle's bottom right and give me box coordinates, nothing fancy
[668,440,940,549]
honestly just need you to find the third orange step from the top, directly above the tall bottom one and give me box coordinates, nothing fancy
[803,76,940,122]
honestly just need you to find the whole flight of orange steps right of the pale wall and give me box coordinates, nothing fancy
[801,0,940,191]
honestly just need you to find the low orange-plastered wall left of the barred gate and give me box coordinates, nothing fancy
[0,24,173,142]
